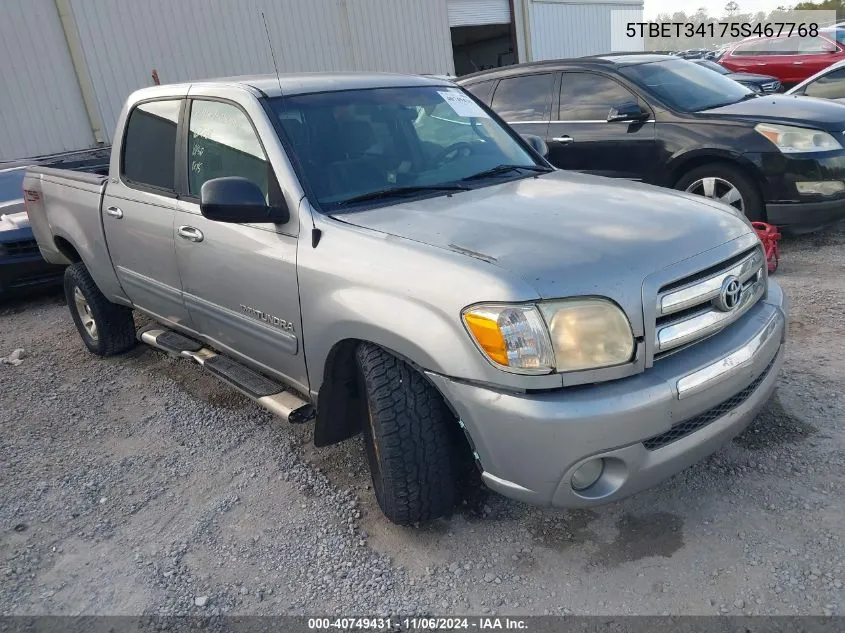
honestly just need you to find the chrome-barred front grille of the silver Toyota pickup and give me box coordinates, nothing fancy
[654,247,766,360]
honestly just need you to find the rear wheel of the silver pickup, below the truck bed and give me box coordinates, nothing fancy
[64,263,137,356]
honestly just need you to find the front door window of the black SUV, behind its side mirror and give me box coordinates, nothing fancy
[558,73,639,121]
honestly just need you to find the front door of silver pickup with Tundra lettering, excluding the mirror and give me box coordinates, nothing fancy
[175,95,308,390]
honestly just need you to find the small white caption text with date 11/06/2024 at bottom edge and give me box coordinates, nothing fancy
[308,617,528,631]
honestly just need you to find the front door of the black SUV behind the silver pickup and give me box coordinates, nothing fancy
[546,72,658,182]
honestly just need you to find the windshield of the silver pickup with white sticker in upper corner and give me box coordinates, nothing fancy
[270,86,538,210]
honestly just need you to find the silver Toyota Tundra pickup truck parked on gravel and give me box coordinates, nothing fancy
[24,74,786,524]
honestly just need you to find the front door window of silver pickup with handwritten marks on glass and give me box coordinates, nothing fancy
[188,100,270,198]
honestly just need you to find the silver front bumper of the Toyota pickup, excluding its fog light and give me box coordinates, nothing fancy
[429,281,787,507]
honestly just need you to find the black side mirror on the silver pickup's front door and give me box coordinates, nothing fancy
[200,176,290,224]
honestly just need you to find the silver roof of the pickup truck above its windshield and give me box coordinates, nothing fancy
[192,72,454,97]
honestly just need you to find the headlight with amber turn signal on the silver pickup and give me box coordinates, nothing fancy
[463,298,634,374]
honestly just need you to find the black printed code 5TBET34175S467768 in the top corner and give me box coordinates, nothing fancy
[625,22,819,38]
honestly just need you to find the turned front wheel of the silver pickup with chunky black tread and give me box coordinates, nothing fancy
[356,343,457,525]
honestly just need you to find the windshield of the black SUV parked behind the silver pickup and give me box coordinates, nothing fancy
[621,60,754,112]
